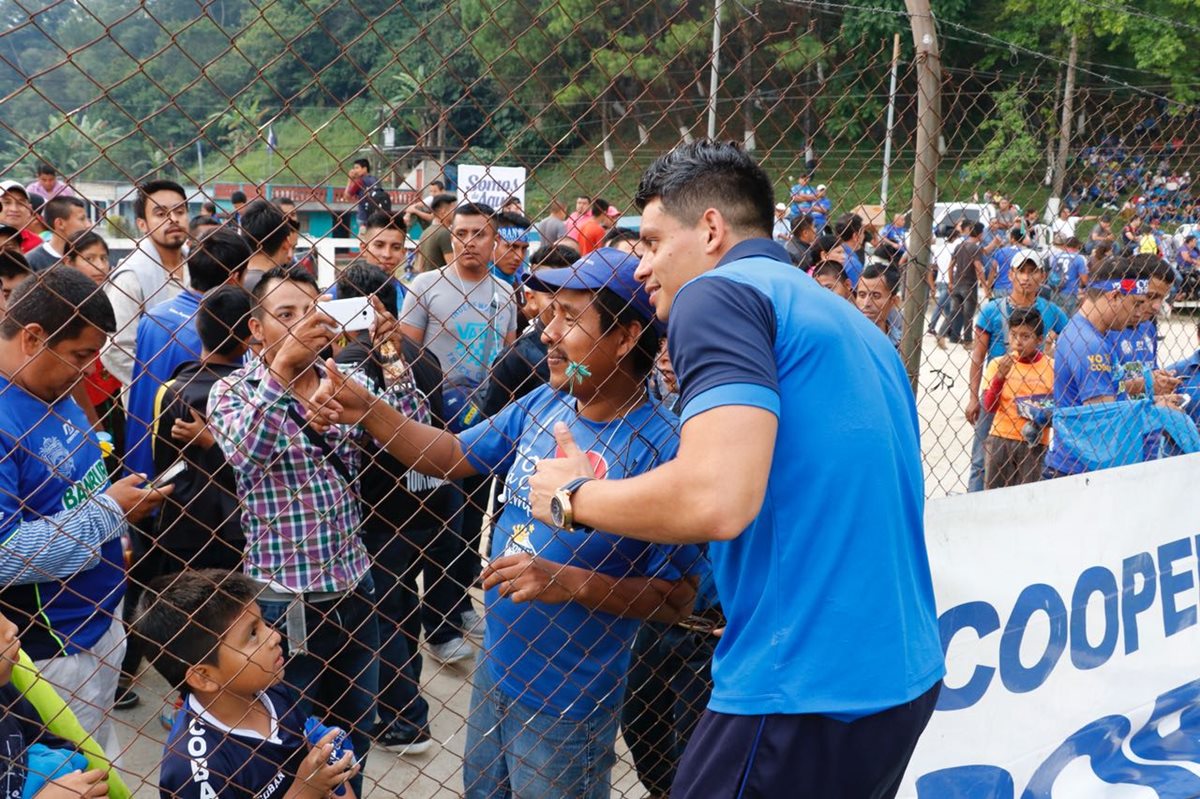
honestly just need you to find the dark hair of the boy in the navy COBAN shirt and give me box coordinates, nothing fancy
[133,569,259,692]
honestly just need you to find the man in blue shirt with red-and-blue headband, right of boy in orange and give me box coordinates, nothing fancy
[1043,256,1166,472]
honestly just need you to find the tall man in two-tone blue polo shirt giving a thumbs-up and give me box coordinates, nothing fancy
[530,140,944,799]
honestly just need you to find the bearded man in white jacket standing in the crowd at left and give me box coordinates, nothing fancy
[100,180,187,386]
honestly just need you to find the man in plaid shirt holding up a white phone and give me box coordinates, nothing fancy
[209,266,422,782]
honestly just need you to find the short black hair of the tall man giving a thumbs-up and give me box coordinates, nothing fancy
[634,139,775,236]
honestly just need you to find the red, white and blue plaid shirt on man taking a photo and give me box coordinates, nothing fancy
[209,360,422,591]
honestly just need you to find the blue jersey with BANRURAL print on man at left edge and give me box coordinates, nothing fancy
[0,378,125,660]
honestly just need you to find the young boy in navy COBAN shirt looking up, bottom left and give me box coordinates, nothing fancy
[136,569,359,799]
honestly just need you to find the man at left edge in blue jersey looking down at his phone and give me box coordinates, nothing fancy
[0,266,169,752]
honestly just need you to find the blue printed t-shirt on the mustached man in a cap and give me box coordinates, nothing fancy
[458,385,701,719]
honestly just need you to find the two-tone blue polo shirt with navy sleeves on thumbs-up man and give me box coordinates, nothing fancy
[667,239,944,720]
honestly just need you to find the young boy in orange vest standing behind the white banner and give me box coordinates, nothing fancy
[983,308,1054,488]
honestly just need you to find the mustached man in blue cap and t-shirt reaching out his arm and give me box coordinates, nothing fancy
[322,248,703,799]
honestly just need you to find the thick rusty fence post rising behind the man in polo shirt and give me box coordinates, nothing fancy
[900,0,942,394]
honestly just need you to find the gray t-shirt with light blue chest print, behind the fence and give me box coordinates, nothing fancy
[400,265,517,388]
